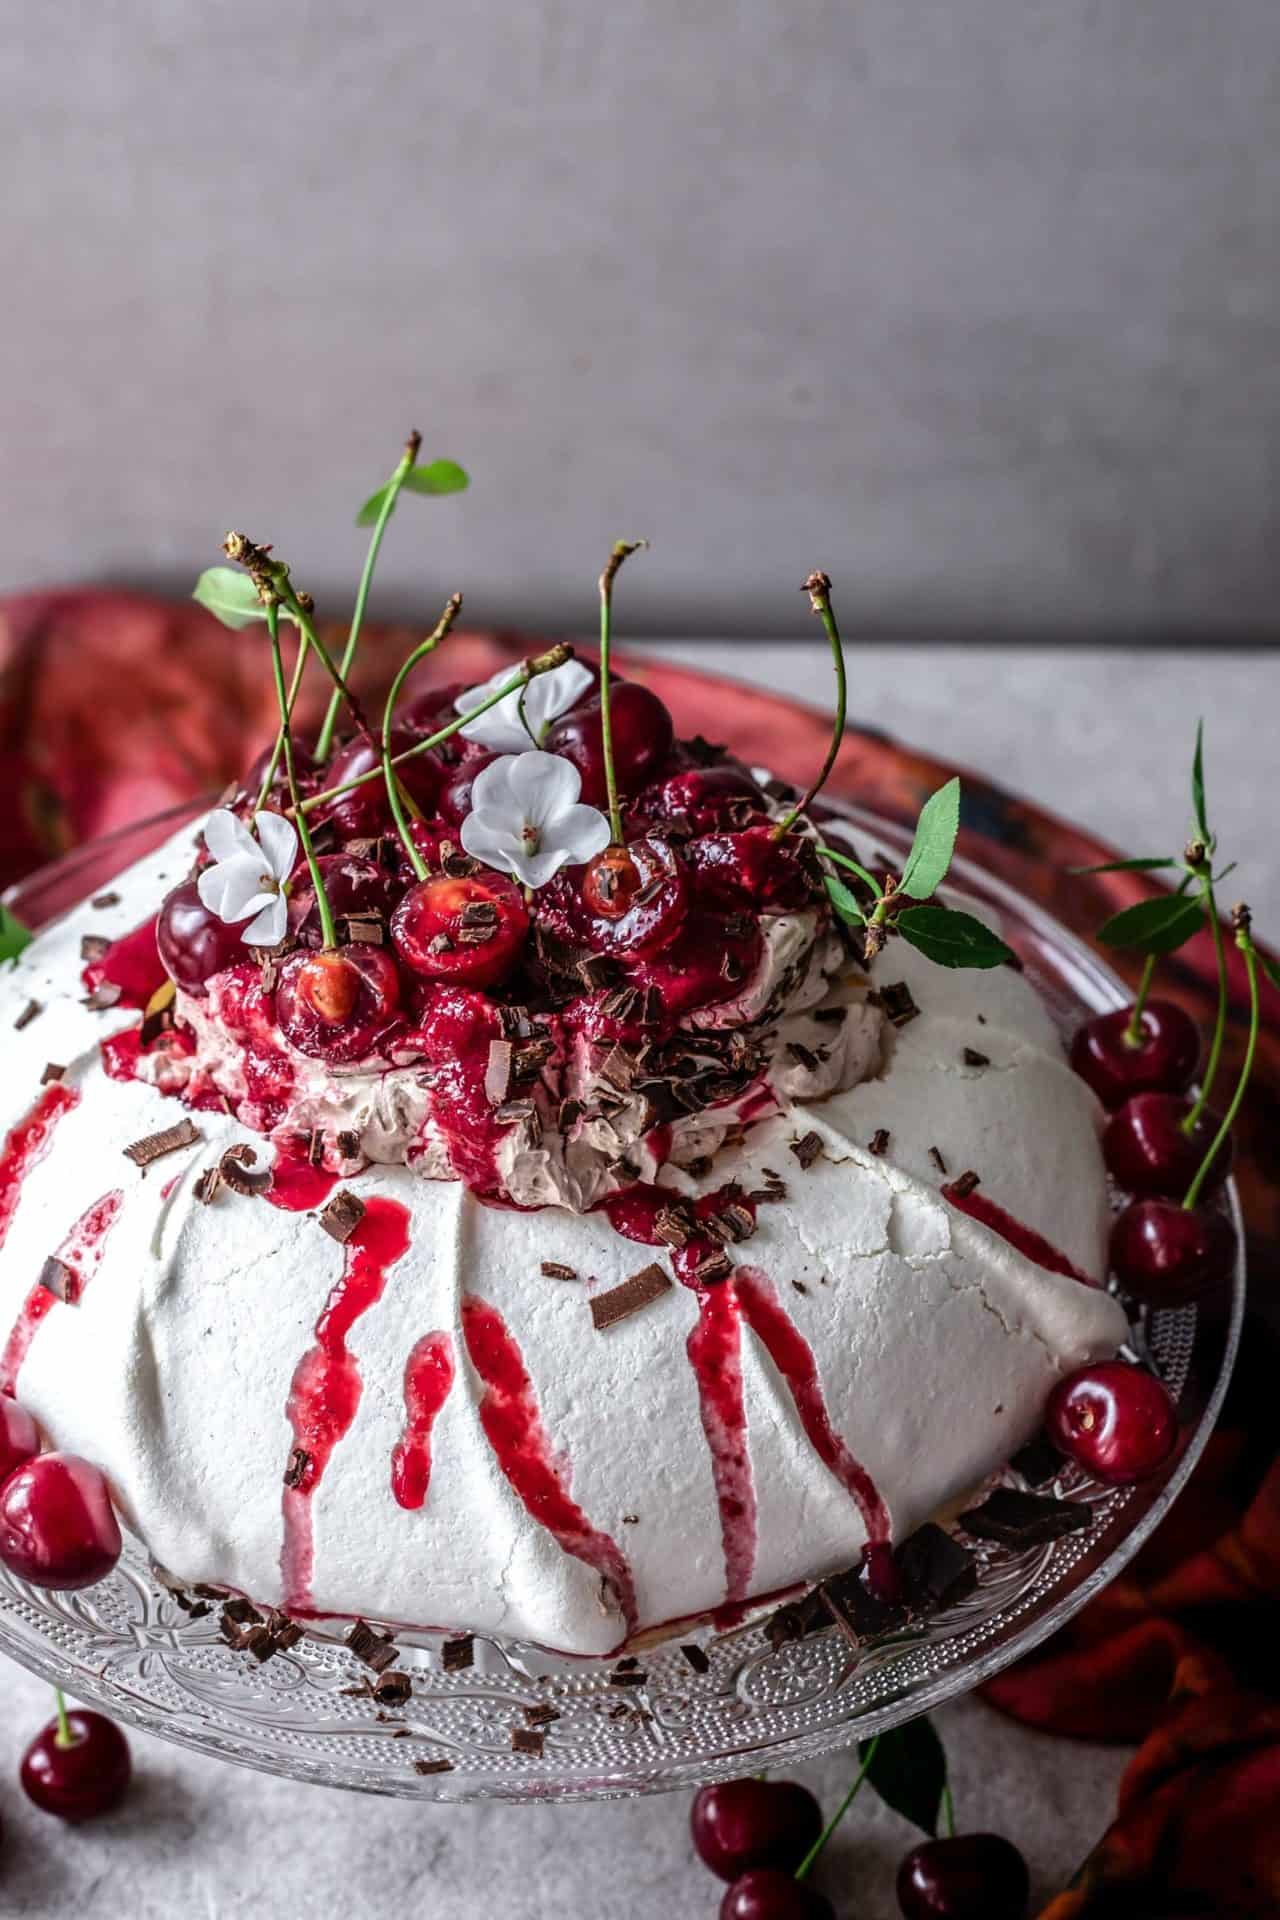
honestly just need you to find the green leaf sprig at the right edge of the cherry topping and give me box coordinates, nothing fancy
[819,780,1013,968]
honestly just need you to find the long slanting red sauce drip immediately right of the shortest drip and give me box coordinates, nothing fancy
[462,1294,637,1634]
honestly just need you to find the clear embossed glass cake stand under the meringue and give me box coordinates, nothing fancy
[0,806,1244,1801]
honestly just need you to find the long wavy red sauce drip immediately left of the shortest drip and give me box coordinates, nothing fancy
[280,1198,409,1611]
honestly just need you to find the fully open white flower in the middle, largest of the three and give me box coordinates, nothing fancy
[462,753,608,887]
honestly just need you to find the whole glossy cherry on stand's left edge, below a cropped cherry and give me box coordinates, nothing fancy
[0,1453,121,1594]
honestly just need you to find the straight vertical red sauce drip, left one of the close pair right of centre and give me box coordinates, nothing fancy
[685,1286,756,1607]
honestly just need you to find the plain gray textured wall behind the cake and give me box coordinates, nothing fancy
[0,0,1280,637]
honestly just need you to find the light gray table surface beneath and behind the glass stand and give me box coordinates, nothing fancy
[0,641,1280,1920]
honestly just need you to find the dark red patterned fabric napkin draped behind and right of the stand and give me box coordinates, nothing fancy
[0,589,1280,1920]
